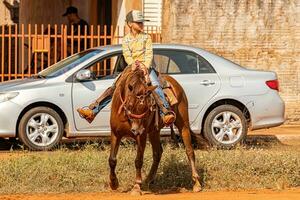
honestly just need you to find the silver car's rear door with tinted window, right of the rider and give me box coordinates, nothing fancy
[153,49,220,123]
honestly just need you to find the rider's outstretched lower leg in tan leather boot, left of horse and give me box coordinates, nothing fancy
[77,87,114,123]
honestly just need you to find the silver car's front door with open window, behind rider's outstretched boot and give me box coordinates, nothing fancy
[72,53,121,131]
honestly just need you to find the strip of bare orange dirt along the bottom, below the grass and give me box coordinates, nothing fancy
[0,188,300,200]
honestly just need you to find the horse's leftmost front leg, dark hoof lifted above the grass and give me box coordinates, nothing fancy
[108,132,121,190]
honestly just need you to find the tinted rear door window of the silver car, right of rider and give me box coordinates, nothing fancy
[153,50,198,74]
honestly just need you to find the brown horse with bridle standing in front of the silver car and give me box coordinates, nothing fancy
[109,67,201,194]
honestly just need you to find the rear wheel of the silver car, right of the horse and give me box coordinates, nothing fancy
[204,105,248,148]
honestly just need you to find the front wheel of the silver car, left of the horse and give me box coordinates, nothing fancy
[18,107,64,151]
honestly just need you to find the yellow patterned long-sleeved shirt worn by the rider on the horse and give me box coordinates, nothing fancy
[122,32,153,69]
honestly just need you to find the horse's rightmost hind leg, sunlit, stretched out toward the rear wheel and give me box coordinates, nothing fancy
[176,122,201,192]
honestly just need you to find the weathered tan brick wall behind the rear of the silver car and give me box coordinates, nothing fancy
[162,0,300,125]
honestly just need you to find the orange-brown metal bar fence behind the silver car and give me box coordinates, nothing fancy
[0,24,161,82]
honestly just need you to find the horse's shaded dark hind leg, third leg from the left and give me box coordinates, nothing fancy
[145,132,163,184]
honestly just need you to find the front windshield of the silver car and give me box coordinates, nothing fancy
[38,49,102,78]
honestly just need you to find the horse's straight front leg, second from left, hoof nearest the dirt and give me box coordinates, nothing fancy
[131,133,147,195]
